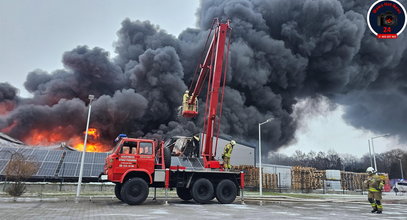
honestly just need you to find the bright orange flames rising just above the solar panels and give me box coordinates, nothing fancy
[19,127,111,152]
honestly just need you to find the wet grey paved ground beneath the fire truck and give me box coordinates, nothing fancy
[0,193,407,220]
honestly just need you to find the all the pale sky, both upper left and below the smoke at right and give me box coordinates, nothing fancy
[0,0,405,156]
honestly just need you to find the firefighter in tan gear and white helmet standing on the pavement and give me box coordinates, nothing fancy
[364,167,384,214]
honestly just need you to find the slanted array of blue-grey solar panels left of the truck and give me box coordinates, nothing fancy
[0,146,109,178]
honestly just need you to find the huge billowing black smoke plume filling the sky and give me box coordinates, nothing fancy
[0,0,407,155]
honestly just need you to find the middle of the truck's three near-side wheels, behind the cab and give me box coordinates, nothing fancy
[191,178,214,204]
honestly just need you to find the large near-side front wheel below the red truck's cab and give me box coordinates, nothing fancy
[120,177,149,205]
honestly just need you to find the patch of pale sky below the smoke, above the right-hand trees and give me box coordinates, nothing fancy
[279,102,405,156]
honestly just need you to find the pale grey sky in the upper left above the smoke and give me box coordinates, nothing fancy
[0,0,199,96]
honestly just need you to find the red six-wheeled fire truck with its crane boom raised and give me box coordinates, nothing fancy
[101,19,244,205]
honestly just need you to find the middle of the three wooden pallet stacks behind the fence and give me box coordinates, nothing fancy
[291,166,325,190]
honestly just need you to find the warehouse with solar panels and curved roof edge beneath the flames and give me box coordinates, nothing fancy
[0,133,108,182]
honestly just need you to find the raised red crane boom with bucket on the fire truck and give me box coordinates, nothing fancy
[182,20,231,168]
